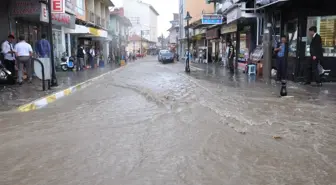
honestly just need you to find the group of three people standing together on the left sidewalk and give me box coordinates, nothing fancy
[0,34,51,85]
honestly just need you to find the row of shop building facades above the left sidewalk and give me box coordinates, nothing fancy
[0,0,114,66]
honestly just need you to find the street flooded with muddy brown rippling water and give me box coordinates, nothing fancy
[0,57,336,185]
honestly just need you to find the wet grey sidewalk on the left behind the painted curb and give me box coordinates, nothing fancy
[0,64,119,111]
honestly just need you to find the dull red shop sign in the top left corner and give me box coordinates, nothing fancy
[11,0,41,17]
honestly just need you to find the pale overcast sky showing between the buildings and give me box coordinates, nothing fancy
[111,0,178,36]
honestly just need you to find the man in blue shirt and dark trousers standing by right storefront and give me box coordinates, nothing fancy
[274,36,287,81]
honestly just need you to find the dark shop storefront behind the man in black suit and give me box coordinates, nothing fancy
[266,0,336,81]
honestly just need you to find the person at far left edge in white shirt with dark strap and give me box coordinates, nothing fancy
[1,34,16,77]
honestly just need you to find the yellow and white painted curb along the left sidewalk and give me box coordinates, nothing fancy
[16,65,126,112]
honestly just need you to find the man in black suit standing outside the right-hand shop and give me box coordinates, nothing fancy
[305,26,323,86]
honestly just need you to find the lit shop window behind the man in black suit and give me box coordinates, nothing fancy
[306,16,336,57]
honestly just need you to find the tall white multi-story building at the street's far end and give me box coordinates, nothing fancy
[123,0,159,42]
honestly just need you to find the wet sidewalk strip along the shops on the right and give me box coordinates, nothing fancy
[190,63,336,104]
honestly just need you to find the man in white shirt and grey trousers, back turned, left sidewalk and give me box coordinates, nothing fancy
[14,35,33,85]
